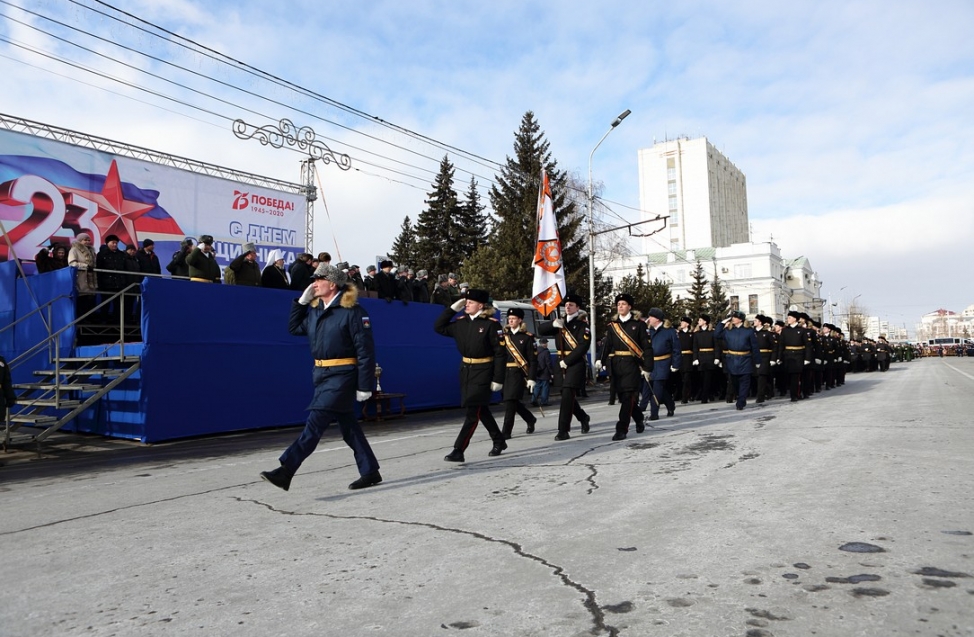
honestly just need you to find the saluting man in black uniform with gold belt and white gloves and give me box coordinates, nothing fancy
[433,289,507,462]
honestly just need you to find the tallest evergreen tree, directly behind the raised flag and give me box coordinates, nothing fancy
[463,111,589,299]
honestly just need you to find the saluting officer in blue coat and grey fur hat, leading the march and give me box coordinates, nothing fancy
[260,264,382,491]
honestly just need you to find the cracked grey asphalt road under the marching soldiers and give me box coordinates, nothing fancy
[0,358,974,637]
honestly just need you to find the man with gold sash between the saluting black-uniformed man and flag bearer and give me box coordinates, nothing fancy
[501,307,538,440]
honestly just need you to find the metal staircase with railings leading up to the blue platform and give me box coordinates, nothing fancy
[3,284,141,453]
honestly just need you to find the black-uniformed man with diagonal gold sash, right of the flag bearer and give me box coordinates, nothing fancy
[595,294,653,440]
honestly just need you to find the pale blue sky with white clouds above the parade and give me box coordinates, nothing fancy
[0,0,974,326]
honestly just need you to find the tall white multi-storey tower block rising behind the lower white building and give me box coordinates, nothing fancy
[639,137,750,253]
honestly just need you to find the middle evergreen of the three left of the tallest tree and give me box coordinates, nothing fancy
[413,156,463,280]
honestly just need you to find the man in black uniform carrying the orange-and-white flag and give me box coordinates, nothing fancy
[538,293,592,440]
